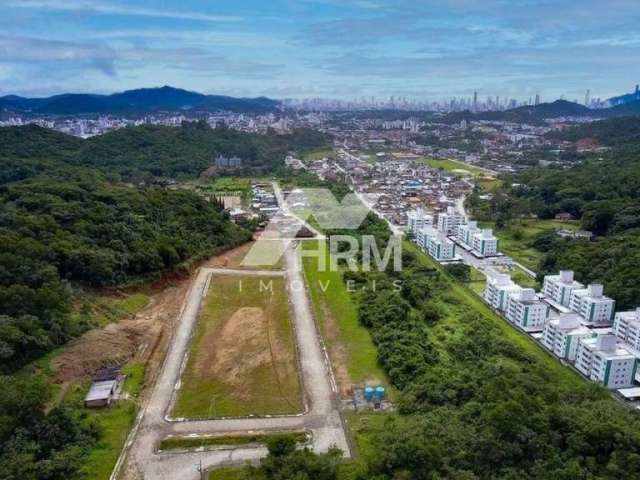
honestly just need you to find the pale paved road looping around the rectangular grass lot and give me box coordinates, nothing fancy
[117,253,349,480]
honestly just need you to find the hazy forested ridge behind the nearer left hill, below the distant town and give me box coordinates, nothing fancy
[0,122,330,183]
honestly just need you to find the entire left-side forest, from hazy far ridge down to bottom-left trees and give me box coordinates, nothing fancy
[0,123,327,480]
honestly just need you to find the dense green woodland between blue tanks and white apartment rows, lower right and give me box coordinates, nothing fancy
[234,210,640,480]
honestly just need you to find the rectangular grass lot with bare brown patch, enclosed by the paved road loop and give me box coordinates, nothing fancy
[173,275,303,418]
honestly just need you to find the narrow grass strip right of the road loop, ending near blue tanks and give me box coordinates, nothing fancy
[303,241,388,394]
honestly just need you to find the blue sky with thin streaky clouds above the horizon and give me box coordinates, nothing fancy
[0,0,640,100]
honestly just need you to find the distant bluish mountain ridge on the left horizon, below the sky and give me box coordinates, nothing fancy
[0,86,279,116]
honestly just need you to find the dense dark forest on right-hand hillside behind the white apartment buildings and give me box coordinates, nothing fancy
[468,118,640,310]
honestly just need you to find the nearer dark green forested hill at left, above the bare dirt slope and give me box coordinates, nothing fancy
[0,169,250,371]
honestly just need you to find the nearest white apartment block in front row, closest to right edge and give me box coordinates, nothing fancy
[575,335,638,389]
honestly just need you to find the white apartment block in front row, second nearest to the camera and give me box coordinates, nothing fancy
[541,313,595,361]
